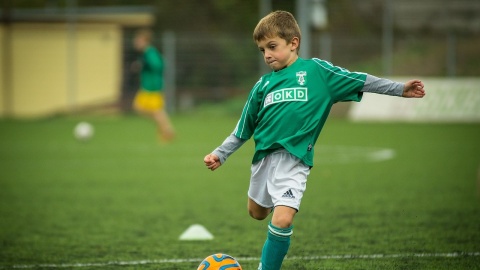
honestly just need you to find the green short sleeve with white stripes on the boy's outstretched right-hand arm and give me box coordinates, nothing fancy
[314,59,367,103]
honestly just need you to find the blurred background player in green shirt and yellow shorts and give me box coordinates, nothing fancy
[132,29,175,141]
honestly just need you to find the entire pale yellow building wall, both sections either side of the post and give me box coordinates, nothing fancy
[9,23,122,117]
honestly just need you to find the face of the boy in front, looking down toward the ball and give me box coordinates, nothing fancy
[257,37,299,71]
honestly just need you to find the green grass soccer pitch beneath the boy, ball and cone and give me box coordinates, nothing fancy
[0,108,480,270]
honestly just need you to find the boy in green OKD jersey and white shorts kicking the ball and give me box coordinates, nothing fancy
[204,11,425,270]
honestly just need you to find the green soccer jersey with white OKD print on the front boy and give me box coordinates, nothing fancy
[234,58,367,166]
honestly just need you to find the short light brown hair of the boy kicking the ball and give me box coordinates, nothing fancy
[253,10,302,52]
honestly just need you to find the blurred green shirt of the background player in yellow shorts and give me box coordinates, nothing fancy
[140,46,163,91]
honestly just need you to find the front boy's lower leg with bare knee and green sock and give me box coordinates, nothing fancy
[258,205,297,270]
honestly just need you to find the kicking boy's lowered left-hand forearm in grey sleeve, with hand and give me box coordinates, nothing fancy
[203,133,247,171]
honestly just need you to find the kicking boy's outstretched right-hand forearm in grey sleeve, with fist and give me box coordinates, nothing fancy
[361,74,425,98]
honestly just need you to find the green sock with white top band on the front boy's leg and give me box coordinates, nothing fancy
[261,222,293,270]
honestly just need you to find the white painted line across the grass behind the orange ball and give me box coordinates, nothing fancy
[0,252,480,269]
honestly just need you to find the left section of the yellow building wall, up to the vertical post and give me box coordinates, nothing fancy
[9,24,67,117]
